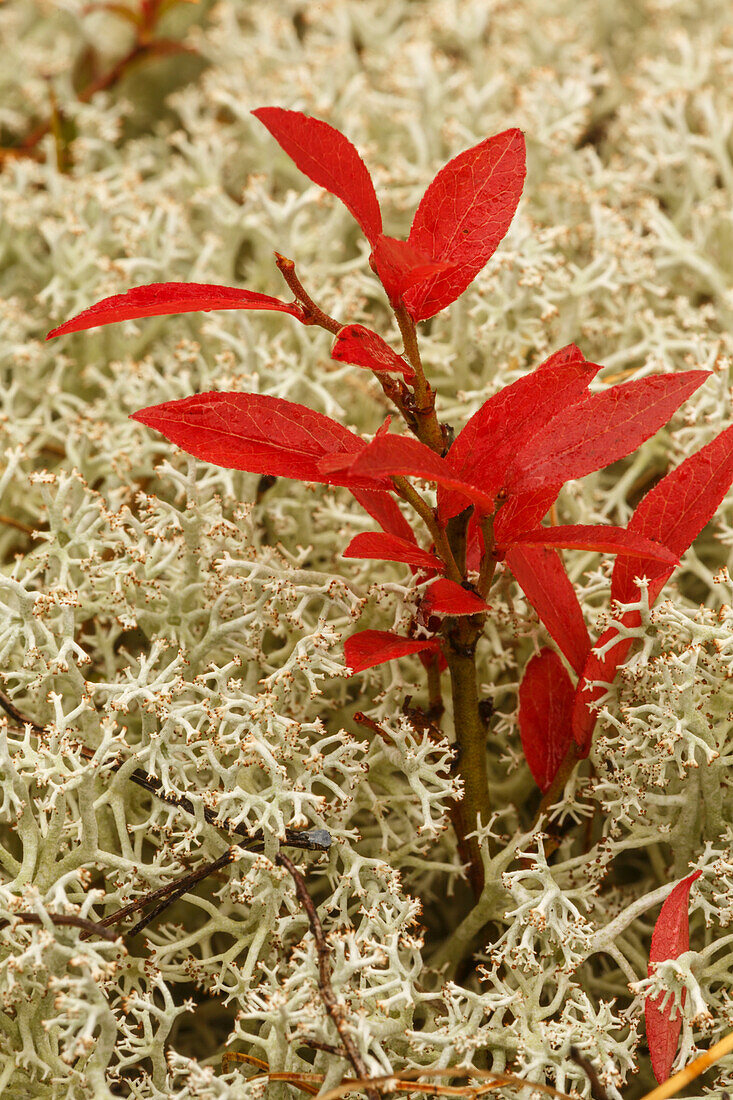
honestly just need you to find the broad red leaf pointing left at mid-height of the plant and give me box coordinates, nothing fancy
[131,393,384,488]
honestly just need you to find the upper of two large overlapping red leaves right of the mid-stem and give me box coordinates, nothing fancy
[438,344,600,519]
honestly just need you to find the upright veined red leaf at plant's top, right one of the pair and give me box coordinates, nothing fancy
[405,130,526,321]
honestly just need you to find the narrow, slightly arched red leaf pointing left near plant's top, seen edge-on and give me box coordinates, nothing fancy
[46,283,303,340]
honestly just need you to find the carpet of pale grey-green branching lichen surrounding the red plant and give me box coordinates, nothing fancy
[0,0,733,1100]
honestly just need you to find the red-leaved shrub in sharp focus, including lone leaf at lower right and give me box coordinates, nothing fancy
[48,107,733,1080]
